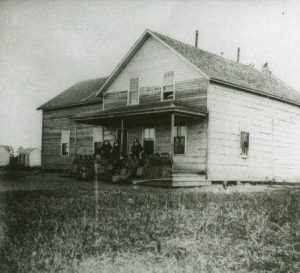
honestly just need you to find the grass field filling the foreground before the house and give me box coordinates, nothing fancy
[0,169,300,272]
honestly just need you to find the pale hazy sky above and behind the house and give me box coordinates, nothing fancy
[0,0,300,149]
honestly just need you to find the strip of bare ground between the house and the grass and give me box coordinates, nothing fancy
[0,166,300,194]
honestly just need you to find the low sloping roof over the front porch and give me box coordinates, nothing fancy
[73,101,207,121]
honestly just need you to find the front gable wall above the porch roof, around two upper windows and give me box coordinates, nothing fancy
[103,37,208,110]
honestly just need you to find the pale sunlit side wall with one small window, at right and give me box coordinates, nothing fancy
[208,84,300,182]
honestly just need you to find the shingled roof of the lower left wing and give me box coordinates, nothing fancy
[38,77,107,110]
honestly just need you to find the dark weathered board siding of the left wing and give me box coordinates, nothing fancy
[42,104,102,169]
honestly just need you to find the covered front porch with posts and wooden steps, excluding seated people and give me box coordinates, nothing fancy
[75,101,207,186]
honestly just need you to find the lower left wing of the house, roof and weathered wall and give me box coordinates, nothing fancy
[38,78,107,170]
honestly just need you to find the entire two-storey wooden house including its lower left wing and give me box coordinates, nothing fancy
[40,30,300,183]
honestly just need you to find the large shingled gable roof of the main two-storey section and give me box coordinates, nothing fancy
[97,30,300,105]
